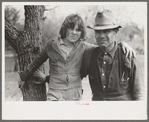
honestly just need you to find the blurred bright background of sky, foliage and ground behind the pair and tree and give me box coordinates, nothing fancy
[5,2,147,101]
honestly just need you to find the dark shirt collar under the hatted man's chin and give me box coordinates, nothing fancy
[99,42,117,58]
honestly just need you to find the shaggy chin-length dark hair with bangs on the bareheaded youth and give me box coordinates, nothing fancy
[59,14,86,39]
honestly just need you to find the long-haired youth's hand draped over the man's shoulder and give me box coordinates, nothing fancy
[120,41,136,58]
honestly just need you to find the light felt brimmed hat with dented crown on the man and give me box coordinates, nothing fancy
[87,9,122,30]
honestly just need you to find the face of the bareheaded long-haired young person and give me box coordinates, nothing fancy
[66,24,81,43]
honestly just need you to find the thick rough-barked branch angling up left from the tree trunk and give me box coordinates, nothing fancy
[5,18,20,52]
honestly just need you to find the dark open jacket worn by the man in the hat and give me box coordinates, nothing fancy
[81,46,144,101]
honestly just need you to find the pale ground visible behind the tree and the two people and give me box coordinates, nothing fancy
[2,55,144,101]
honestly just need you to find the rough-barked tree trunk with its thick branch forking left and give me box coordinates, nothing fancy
[5,5,46,101]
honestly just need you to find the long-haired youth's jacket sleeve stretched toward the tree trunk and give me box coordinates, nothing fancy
[20,43,48,81]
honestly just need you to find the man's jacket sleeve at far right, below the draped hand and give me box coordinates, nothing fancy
[131,58,144,100]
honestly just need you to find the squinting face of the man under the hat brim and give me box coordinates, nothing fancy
[95,29,116,47]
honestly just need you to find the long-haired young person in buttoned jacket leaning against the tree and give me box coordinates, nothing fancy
[20,14,134,101]
